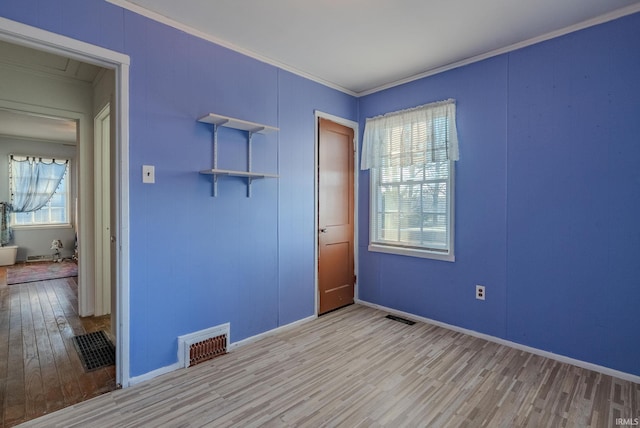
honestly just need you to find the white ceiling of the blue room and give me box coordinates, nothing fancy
[120,0,640,94]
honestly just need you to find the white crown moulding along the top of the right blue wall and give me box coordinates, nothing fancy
[357,4,640,97]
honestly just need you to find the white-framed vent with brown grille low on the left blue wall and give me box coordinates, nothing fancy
[178,323,229,368]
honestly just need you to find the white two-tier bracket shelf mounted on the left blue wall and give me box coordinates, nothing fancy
[198,113,279,197]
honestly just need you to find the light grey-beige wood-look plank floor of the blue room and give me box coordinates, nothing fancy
[12,305,640,428]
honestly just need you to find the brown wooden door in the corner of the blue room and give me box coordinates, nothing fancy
[318,119,355,314]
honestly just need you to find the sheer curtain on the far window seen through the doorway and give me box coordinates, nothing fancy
[10,156,68,213]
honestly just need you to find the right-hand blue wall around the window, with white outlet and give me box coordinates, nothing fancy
[359,14,640,375]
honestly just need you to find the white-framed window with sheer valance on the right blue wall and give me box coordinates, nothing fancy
[361,100,458,261]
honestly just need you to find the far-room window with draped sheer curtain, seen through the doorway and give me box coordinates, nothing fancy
[9,155,70,227]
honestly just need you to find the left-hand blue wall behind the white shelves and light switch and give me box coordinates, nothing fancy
[0,0,357,376]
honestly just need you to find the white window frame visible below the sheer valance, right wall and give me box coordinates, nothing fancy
[368,160,456,262]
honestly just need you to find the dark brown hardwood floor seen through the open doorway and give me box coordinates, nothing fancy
[0,267,115,427]
